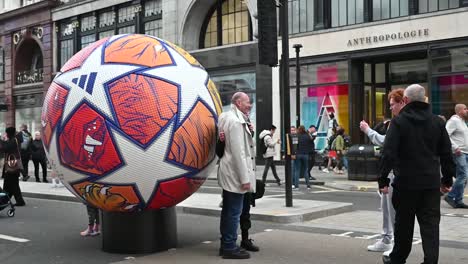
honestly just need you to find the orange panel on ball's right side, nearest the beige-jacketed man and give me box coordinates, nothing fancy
[169,102,216,169]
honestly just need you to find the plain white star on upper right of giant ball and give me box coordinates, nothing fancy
[142,44,216,122]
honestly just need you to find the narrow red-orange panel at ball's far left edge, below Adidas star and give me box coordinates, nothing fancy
[41,82,68,149]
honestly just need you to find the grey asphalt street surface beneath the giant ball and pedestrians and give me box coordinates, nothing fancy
[0,184,468,264]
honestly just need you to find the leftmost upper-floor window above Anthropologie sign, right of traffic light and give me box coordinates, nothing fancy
[288,0,314,34]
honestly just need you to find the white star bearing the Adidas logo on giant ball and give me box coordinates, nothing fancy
[54,47,141,121]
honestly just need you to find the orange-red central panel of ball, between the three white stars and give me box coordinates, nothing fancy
[109,74,178,145]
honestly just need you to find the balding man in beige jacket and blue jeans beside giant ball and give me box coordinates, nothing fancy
[218,92,255,259]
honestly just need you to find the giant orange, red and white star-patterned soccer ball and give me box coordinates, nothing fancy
[41,34,221,212]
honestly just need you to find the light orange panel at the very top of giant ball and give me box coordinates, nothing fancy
[104,35,172,67]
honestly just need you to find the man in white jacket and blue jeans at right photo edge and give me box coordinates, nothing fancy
[445,104,468,208]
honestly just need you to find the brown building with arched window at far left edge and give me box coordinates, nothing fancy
[0,0,58,134]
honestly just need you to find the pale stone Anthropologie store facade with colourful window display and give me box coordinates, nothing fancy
[272,0,468,148]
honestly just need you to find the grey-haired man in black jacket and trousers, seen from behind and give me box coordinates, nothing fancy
[379,84,455,264]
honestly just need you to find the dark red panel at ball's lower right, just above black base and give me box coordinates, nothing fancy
[148,178,205,209]
